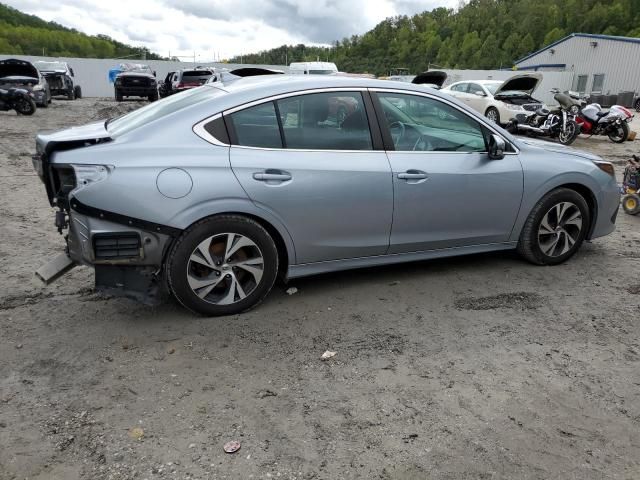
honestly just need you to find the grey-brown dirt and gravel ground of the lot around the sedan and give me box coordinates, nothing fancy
[0,99,640,480]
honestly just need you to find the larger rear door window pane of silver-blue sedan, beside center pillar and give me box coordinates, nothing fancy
[277,92,373,150]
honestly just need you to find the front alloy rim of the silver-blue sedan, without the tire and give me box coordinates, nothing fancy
[538,202,582,257]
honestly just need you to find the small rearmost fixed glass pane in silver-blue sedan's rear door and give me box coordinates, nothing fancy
[229,102,282,148]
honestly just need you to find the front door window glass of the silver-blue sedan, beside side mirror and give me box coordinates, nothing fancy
[378,93,486,152]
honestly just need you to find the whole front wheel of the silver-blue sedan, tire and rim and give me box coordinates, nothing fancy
[517,188,591,265]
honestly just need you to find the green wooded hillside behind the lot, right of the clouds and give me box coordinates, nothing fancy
[229,0,640,75]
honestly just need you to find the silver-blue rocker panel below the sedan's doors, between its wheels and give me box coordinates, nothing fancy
[287,242,518,279]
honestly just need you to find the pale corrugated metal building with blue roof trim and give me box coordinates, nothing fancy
[515,33,640,102]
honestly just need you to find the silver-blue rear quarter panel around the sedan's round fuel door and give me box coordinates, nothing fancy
[52,113,296,263]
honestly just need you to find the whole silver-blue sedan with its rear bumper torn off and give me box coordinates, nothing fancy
[33,75,619,315]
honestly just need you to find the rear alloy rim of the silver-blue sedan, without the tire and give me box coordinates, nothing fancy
[187,233,264,305]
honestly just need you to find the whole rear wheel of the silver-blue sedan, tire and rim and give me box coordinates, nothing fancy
[166,215,278,316]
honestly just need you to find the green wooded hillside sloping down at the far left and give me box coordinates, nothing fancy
[0,3,163,60]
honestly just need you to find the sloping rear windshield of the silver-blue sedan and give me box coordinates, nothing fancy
[105,86,226,137]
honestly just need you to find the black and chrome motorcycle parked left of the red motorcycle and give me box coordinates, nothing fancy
[507,88,580,145]
